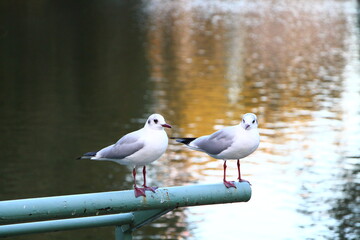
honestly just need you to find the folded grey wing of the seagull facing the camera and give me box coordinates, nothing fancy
[193,130,235,155]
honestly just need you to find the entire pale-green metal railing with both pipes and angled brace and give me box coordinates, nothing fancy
[0,182,251,240]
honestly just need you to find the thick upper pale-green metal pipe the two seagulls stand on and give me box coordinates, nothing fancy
[0,182,251,225]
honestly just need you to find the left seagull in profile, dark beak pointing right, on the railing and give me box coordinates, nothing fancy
[79,114,171,197]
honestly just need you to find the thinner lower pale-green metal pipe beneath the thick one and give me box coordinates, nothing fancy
[0,213,134,237]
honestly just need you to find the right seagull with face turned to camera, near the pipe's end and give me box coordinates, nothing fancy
[172,113,260,188]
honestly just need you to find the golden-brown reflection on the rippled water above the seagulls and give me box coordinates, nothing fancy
[147,1,348,163]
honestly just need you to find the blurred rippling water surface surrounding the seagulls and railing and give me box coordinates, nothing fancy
[0,0,360,240]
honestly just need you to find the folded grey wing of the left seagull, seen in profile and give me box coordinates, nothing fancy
[97,132,144,159]
